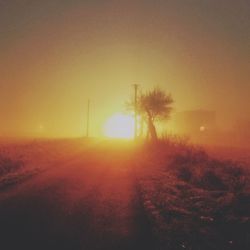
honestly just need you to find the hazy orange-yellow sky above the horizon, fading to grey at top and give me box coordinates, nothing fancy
[0,0,250,137]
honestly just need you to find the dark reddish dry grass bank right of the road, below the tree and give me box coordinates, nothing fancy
[137,140,250,250]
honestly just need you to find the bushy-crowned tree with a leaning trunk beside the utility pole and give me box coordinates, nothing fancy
[138,88,174,141]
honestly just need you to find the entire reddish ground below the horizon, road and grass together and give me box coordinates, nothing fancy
[0,139,250,250]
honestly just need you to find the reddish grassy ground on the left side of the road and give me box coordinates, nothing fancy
[0,140,85,192]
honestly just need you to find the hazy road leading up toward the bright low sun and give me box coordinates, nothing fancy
[0,143,154,250]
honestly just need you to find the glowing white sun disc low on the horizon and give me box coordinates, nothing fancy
[103,114,134,139]
